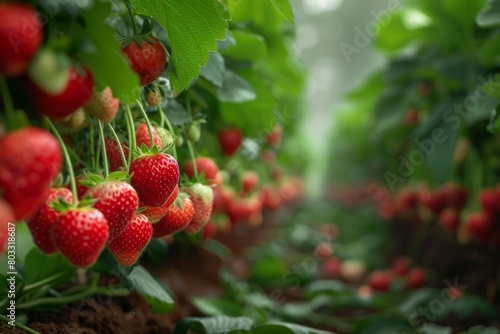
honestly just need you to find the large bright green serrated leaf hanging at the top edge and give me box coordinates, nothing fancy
[131,0,230,91]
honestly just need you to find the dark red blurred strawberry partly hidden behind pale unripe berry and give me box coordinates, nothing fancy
[25,66,94,119]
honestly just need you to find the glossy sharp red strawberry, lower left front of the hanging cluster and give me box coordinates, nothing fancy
[50,207,109,267]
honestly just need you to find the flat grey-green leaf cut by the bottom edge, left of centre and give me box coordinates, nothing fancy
[173,316,253,334]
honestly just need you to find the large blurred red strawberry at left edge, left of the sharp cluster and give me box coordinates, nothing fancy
[0,127,62,220]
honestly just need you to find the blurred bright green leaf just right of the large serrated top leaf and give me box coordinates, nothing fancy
[223,30,268,62]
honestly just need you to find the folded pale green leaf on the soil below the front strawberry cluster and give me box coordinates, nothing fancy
[123,266,174,313]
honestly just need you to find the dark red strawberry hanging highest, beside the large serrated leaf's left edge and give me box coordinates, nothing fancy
[123,36,167,86]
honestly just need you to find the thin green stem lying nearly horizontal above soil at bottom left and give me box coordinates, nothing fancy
[17,287,129,311]
